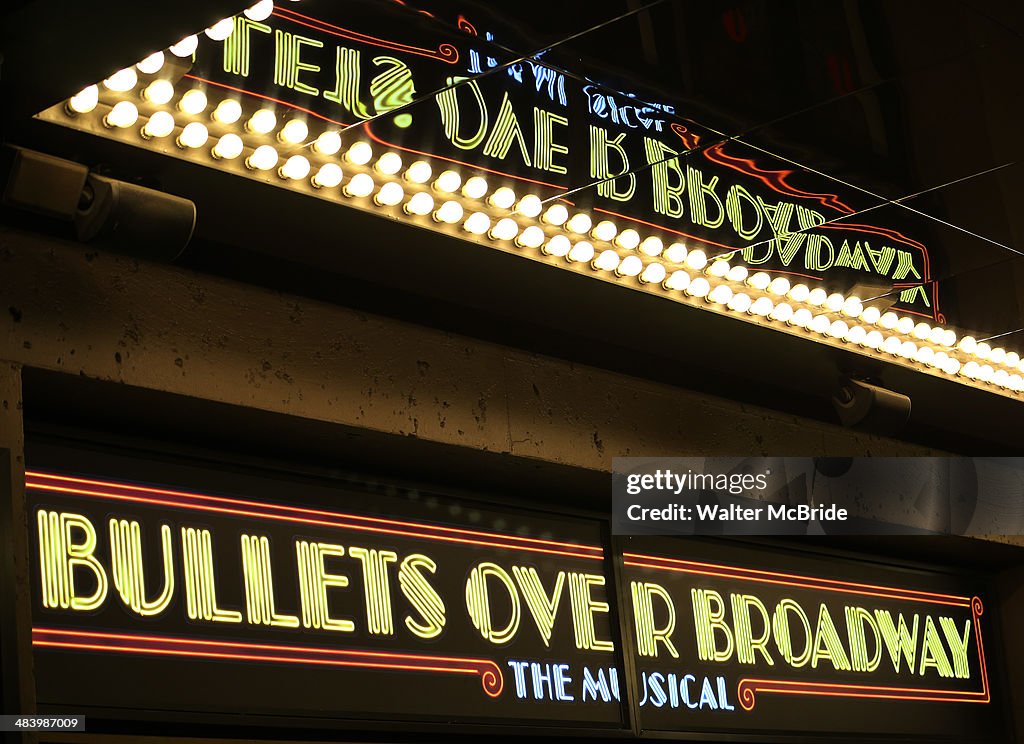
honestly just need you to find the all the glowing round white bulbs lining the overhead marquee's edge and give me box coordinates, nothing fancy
[59,11,1024,393]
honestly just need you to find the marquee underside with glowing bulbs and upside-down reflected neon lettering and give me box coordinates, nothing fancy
[32,0,1024,394]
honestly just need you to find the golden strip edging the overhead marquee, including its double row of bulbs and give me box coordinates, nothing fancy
[46,0,1024,399]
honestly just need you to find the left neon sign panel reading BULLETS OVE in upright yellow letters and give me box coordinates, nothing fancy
[28,472,625,728]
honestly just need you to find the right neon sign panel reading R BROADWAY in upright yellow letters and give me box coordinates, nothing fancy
[623,538,1001,741]
